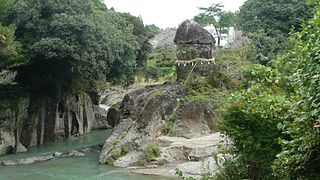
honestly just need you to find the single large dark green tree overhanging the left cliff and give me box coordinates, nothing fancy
[8,0,136,91]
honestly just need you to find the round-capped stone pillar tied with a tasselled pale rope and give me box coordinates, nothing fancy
[174,20,216,81]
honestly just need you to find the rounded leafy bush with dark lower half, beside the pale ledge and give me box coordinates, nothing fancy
[220,65,290,179]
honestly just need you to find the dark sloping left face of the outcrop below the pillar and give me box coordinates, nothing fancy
[100,85,179,163]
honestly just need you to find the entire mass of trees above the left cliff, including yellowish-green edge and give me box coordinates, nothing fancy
[0,0,151,96]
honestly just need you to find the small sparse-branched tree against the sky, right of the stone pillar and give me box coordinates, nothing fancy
[193,4,235,46]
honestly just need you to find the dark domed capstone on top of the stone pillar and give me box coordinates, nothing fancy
[174,20,216,44]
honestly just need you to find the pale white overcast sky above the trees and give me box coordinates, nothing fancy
[104,0,245,29]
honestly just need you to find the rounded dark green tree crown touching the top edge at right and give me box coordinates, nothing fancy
[238,0,313,36]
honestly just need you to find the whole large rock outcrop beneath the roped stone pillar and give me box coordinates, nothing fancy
[99,84,222,177]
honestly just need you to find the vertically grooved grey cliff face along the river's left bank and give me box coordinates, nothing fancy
[0,94,95,155]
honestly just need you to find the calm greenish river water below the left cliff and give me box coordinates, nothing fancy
[0,131,169,180]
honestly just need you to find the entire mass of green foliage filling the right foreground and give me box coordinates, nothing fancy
[217,2,320,179]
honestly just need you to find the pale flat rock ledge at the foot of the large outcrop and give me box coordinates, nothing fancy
[127,133,223,179]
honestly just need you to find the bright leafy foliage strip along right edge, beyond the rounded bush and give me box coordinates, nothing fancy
[274,4,320,179]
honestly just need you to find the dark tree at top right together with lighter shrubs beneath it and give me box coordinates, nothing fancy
[237,0,313,65]
